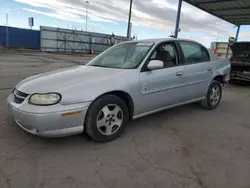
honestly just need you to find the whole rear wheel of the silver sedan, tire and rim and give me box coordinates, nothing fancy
[201,80,222,110]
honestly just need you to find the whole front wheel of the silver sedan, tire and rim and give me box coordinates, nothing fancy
[85,95,129,142]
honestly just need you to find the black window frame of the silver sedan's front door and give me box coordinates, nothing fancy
[141,40,184,72]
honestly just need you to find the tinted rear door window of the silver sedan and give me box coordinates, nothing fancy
[180,42,210,64]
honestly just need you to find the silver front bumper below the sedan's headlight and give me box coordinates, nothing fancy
[7,94,90,137]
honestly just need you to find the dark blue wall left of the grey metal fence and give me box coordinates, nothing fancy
[0,26,40,49]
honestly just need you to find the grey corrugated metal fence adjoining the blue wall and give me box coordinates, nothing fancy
[40,26,127,53]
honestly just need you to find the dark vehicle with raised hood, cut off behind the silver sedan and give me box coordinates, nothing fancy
[230,42,250,81]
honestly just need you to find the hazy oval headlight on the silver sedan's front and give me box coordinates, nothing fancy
[29,93,62,106]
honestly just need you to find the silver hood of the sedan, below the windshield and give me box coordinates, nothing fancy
[16,66,126,94]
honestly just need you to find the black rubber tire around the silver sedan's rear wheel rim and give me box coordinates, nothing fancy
[201,80,222,110]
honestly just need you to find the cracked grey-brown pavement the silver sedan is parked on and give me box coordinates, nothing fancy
[0,53,250,188]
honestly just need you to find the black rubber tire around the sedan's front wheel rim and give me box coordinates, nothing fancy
[84,95,129,142]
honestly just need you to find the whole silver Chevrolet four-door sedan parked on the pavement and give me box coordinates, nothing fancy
[7,38,230,142]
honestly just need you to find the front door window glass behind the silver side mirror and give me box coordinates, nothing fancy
[150,43,177,68]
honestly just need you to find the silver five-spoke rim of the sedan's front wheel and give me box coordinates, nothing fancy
[96,104,123,136]
